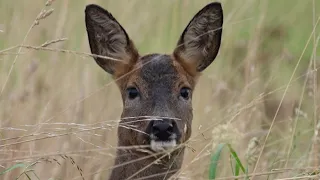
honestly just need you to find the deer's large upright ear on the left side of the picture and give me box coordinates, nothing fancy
[85,4,139,75]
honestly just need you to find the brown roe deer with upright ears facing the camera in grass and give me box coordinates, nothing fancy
[85,2,223,180]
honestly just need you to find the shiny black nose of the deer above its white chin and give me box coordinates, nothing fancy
[151,121,175,141]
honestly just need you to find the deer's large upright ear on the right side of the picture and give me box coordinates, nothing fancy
[174,2,223,72]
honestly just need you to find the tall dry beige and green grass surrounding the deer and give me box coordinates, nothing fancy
[0,0,320,180]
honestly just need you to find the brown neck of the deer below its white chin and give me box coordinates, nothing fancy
[109,147,184,180]
